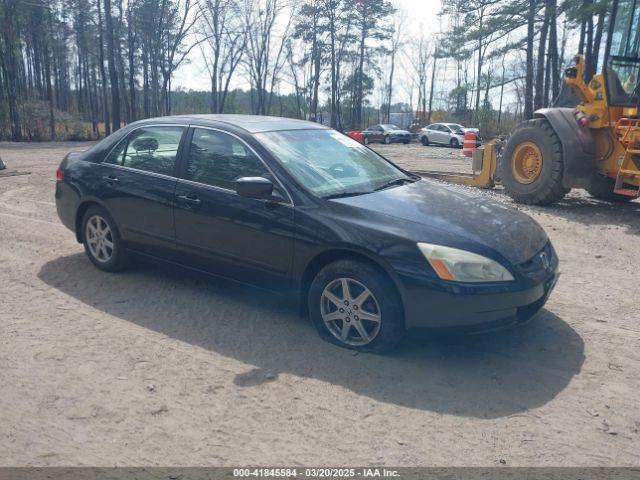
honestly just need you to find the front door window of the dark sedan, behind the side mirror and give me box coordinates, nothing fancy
[186,128,274,190]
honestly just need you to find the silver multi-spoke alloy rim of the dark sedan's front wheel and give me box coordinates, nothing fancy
[320,278,382,346]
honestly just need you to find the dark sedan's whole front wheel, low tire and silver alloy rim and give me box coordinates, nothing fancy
[307,260,405,353]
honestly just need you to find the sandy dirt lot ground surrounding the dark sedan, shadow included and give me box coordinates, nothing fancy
[0,143,640,466]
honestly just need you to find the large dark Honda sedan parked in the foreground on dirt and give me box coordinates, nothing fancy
[55,115,558,352]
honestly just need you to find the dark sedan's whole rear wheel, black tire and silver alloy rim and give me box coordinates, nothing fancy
[81,206,128,272]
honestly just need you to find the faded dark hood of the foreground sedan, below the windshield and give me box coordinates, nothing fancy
[333,179,548,264]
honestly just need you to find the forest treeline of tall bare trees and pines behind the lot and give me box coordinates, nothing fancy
[0,0,610,141]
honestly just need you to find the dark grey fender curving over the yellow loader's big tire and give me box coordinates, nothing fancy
[534,108,596,188]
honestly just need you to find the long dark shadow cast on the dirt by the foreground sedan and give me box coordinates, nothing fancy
[38,254,584,418]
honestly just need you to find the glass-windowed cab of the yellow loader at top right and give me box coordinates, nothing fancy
[604,0,640,107]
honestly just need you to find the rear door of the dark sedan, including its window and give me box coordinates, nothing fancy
[98,125,187,257]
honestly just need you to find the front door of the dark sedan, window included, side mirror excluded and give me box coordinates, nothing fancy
[175,127,294,288]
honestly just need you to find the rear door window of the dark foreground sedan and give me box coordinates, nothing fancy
[105,126,185,176]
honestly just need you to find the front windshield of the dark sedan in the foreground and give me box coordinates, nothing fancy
[255,129,412,197]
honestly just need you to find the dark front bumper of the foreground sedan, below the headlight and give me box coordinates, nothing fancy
[403,266,559,331]
